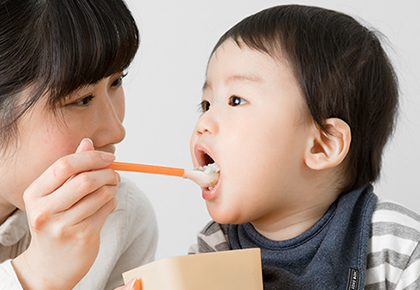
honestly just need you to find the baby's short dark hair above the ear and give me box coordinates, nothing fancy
[212,5,399,192]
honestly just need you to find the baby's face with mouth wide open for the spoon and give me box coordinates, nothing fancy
[191,40,313,228]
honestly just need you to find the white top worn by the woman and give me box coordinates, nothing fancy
[0,179,157,290]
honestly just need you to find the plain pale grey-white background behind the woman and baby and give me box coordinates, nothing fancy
[117,0,420,259]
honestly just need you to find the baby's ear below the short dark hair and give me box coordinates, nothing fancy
[305,118,351,170]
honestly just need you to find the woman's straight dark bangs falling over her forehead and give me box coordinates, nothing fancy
[44,0,139,105]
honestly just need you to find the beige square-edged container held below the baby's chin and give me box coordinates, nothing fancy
[123,249,263,290]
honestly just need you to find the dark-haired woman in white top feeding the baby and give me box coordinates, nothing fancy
[0,0,157,289]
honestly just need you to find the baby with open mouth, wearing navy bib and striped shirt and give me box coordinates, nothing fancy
[190,5,420,290]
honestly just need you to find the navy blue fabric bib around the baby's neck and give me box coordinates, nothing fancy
[229,185,378,290]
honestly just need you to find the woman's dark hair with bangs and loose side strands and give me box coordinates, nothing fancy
[0,0,139,152]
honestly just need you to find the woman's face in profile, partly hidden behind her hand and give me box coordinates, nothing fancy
[0,73,125,209]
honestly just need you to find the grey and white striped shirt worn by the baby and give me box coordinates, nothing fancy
[189,201,420,290]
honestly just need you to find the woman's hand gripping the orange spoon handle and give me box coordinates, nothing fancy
[13,140,120,290]
